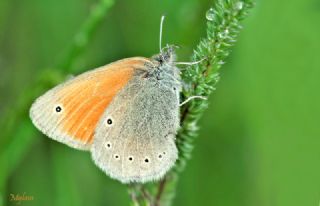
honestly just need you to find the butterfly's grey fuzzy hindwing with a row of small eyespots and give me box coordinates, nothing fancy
[91,63,181,183]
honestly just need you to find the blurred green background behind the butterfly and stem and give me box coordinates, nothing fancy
[0,0,320,206]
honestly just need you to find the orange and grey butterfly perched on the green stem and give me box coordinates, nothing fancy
[30,17,202,183]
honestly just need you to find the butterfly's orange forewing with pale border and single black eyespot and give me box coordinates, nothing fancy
[30,57,150,150]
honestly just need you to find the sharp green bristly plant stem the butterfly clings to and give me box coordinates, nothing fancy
[127,0,253,206]
